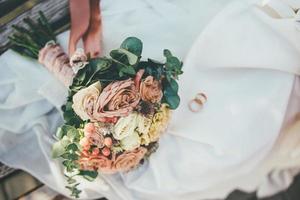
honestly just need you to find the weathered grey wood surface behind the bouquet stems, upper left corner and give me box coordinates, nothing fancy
[0,0,69,53]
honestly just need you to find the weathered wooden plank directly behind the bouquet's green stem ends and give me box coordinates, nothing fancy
[0,0,69,53]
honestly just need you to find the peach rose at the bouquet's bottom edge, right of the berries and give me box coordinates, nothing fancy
[113,147,147,172]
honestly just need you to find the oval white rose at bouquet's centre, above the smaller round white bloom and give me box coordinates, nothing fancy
[113,113,137,140]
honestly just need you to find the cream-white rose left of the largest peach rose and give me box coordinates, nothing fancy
[72,81,101,120]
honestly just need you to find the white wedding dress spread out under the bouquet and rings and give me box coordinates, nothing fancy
[0,0,300,200]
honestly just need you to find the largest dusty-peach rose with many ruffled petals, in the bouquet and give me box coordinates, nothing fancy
[93,79,140,121]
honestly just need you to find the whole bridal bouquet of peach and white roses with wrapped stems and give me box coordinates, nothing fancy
[10,13,183,197]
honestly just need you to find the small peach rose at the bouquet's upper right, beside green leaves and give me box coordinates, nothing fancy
[140,76,163,103]
